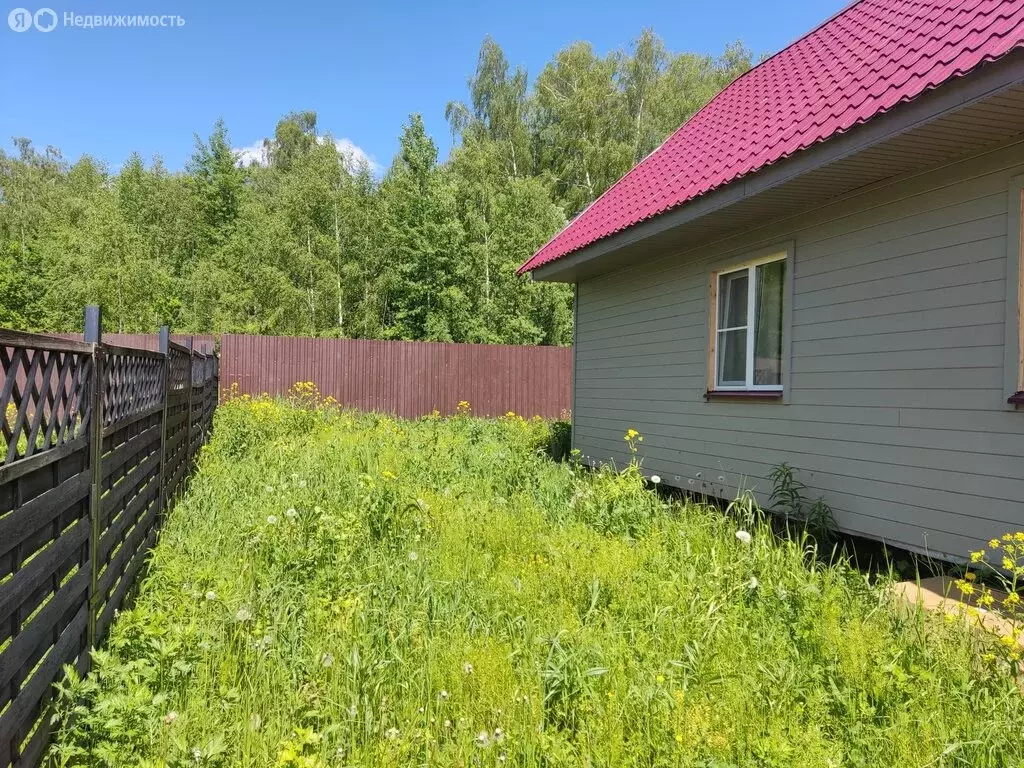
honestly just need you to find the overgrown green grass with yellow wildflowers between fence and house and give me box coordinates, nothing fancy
[54,400,1024,768]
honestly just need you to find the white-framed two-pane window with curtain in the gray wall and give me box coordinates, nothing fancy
[709,253,785,393]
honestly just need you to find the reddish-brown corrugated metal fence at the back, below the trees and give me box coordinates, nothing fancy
[220,334,572,418]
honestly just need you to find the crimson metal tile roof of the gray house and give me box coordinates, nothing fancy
[519,0,1024,272]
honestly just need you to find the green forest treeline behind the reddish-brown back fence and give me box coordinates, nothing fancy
[0,32,752,344]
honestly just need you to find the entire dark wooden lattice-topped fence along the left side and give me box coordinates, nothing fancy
[0,307,218,768]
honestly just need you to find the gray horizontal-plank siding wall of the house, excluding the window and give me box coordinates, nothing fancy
[573,142,1024,558]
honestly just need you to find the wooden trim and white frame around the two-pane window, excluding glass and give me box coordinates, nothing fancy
[705,252,793,401]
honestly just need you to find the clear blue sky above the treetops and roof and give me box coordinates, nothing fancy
[0,0,846,169]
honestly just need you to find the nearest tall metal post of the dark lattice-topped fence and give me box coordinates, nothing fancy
[83,304,105,648]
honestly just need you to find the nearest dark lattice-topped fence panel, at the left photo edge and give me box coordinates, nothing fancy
[0,339,92,766]
